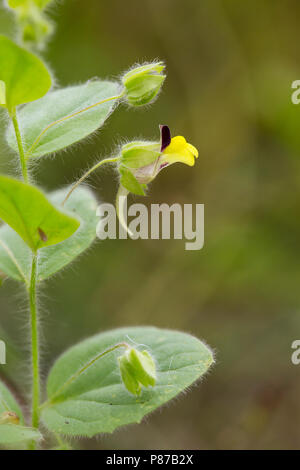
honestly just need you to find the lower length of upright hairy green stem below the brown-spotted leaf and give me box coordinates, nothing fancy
[29,253,40,428]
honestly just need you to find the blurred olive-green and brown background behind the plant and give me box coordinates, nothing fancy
[0,0,300,449]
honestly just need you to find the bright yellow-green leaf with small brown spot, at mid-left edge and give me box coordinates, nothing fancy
[0,176,80,251]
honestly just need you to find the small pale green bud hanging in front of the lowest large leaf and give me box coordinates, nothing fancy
[119,348,156,395]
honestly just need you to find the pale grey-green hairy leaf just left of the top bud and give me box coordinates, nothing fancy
[6,80,120,157]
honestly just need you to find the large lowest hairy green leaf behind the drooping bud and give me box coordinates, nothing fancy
[42,327,213,437]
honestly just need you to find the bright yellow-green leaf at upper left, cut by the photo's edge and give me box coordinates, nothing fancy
[0,35,51,111]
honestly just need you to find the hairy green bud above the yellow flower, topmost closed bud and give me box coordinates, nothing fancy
[122,62,166,106]
